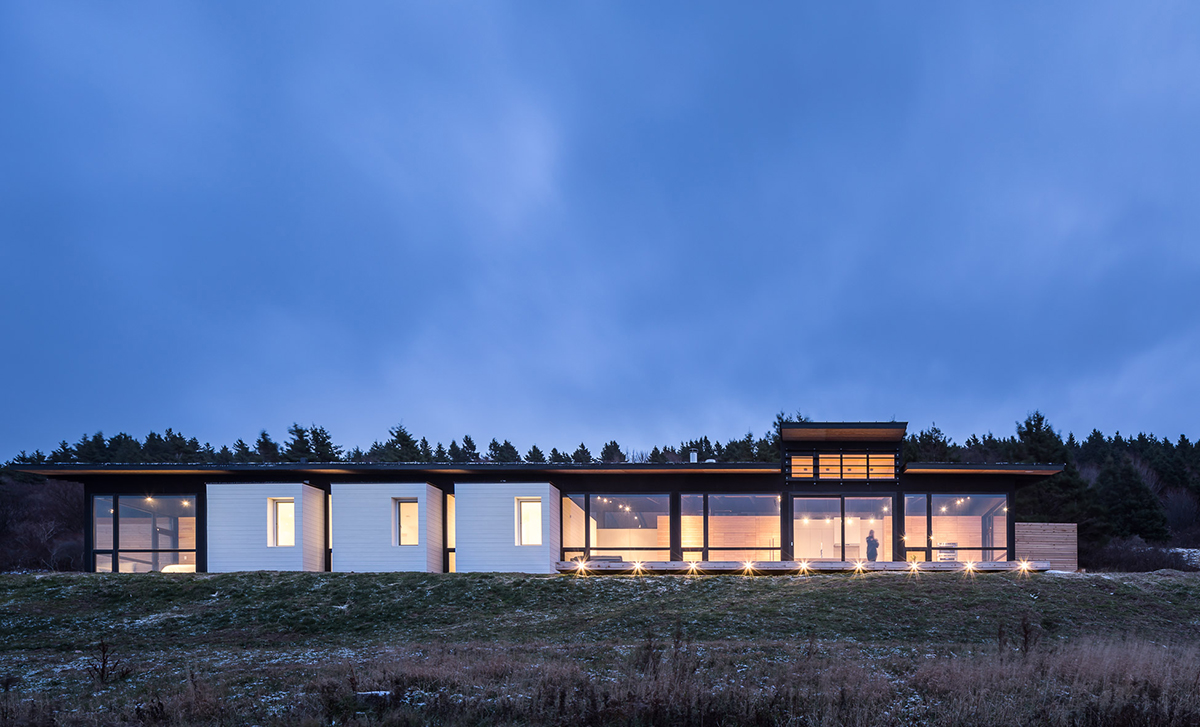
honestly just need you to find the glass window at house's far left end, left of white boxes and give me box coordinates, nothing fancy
[91,495,196,572]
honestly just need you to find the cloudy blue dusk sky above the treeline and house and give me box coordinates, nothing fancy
[0,0,1200,461]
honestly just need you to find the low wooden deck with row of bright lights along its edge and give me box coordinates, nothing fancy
[554,560,1050,576]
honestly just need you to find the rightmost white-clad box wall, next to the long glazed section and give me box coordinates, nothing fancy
[455,482,562,573]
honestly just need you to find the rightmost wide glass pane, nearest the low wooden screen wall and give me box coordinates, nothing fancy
[930,494,1008,561]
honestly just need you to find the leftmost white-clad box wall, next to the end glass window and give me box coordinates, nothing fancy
[206,482,325,573]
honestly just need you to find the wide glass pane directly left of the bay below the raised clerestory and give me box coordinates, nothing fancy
[708,494,780,560]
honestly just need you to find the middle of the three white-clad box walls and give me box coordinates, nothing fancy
[332,482,443,573]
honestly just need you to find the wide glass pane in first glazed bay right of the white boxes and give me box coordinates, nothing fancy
[588,494,671,561]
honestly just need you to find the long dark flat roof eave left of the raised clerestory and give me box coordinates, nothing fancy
[13,462,779,479]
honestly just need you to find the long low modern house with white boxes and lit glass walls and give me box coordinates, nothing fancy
[20,422,1062,573]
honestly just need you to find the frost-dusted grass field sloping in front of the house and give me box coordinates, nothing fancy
[0,571,1200,725]
